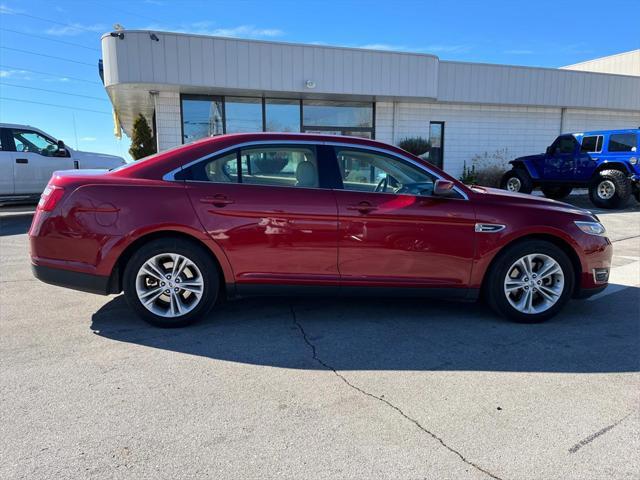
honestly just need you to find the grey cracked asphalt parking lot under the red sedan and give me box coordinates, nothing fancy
[0,197,640,480]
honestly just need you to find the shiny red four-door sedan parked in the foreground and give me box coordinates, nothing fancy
[29,133,612,327]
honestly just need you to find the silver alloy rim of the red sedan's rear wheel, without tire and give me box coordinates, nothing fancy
[136,253,204,318]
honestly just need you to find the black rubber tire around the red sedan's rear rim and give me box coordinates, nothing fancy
[123,238,220,328]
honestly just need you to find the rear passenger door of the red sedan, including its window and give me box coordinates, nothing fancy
[184,144,339,292]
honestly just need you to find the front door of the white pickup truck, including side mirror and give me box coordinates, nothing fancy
[10,129,74,194]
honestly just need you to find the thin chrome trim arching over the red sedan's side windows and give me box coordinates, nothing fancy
[162,140,469,200]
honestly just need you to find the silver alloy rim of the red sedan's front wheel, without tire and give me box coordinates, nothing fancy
[504,253,564,314]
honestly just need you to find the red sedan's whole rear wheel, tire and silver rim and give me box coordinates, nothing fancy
[123,238,220,327]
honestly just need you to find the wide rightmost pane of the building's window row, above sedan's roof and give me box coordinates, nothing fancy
[302,100,373,128]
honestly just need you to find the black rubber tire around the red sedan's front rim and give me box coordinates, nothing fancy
[484,240,575,323]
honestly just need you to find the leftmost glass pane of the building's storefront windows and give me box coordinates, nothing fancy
[182,96,224,143]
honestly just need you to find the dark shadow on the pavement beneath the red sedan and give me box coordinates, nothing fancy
[91,288,640,373]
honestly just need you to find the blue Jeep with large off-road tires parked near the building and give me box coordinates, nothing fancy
[500,128,640,208]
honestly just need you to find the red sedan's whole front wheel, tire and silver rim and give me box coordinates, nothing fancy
[485,240,575,323]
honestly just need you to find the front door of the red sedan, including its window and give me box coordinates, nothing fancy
[335,147,475,288]
